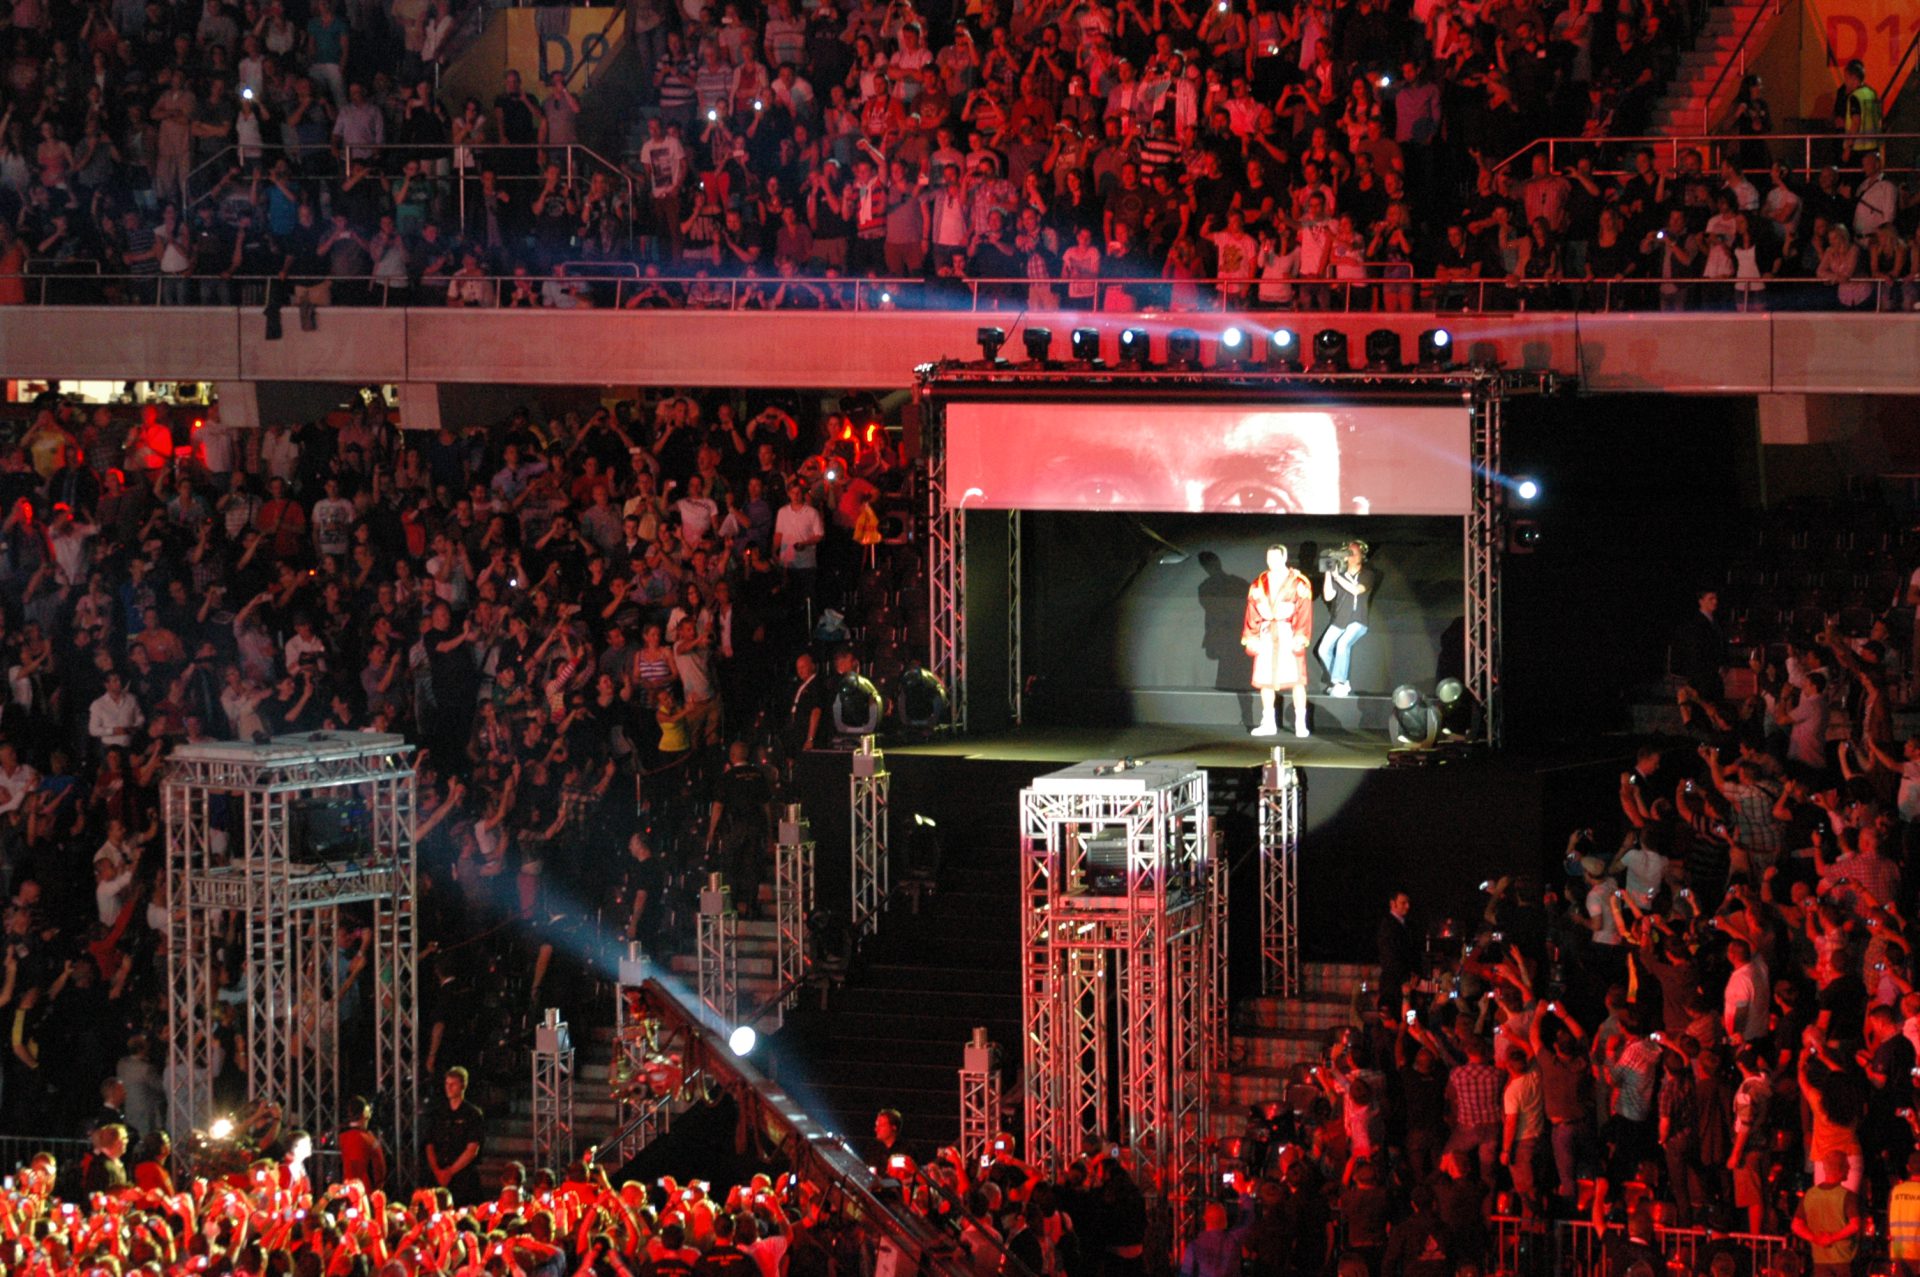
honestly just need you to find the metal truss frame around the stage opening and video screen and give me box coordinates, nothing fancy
[918,361,1571,749]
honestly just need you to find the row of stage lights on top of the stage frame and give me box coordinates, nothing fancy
[975,326,1453,373]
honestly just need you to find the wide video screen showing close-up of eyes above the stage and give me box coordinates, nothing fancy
[947,403,1473,515]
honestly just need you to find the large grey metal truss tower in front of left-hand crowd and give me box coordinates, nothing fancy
[161,732,420,1175]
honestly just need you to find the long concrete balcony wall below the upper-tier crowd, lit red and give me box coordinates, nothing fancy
[0,307,1920,394]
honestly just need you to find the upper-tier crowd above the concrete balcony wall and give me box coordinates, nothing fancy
[0,0,1920,311]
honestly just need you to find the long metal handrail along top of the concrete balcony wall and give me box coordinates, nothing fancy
[15,261,1920,314]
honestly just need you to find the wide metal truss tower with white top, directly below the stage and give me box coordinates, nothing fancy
[1020,760,1223,1219]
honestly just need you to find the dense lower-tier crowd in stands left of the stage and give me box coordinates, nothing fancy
[0,380,924,1135]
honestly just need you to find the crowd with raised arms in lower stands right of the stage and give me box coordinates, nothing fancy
[1217,602,1920,1277]
